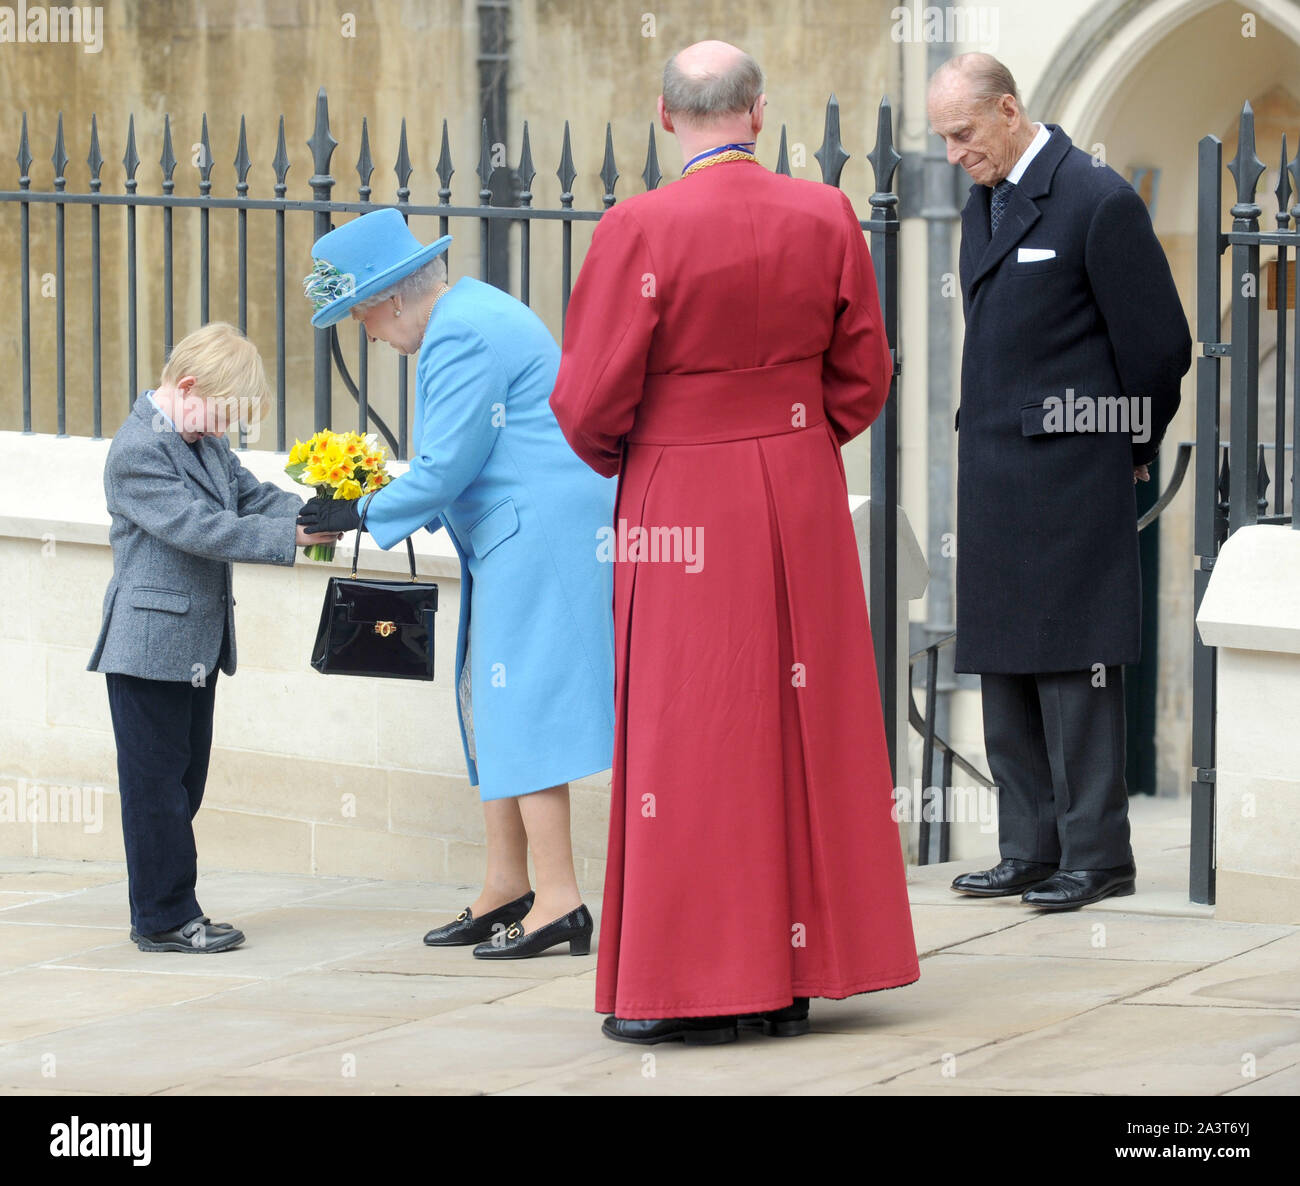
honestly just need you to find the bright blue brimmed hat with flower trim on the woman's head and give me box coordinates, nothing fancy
[303,207,451,328]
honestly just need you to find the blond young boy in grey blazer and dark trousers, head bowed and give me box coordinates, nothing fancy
[87,323,339,952]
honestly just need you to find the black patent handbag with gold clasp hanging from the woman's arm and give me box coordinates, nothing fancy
[312,493,438,680]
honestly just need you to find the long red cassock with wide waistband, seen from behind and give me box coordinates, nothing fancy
[551,152,919,1018]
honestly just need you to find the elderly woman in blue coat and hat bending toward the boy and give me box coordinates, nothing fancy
[299,209,614,960]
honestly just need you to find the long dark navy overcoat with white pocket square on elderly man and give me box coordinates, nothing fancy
[956,124,1192,672]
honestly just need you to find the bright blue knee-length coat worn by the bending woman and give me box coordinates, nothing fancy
[365,277,615,800]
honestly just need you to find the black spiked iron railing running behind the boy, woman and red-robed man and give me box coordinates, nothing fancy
[0,87,901,780]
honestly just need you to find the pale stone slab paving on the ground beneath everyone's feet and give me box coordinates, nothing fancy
[0,853,1300,1095]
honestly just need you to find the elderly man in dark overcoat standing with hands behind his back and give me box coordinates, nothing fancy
[928,53,1191,909]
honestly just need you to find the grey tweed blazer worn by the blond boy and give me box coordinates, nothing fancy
[86,393,304,683]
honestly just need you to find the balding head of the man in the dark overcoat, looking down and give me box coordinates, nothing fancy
[926,53,1035,186]
